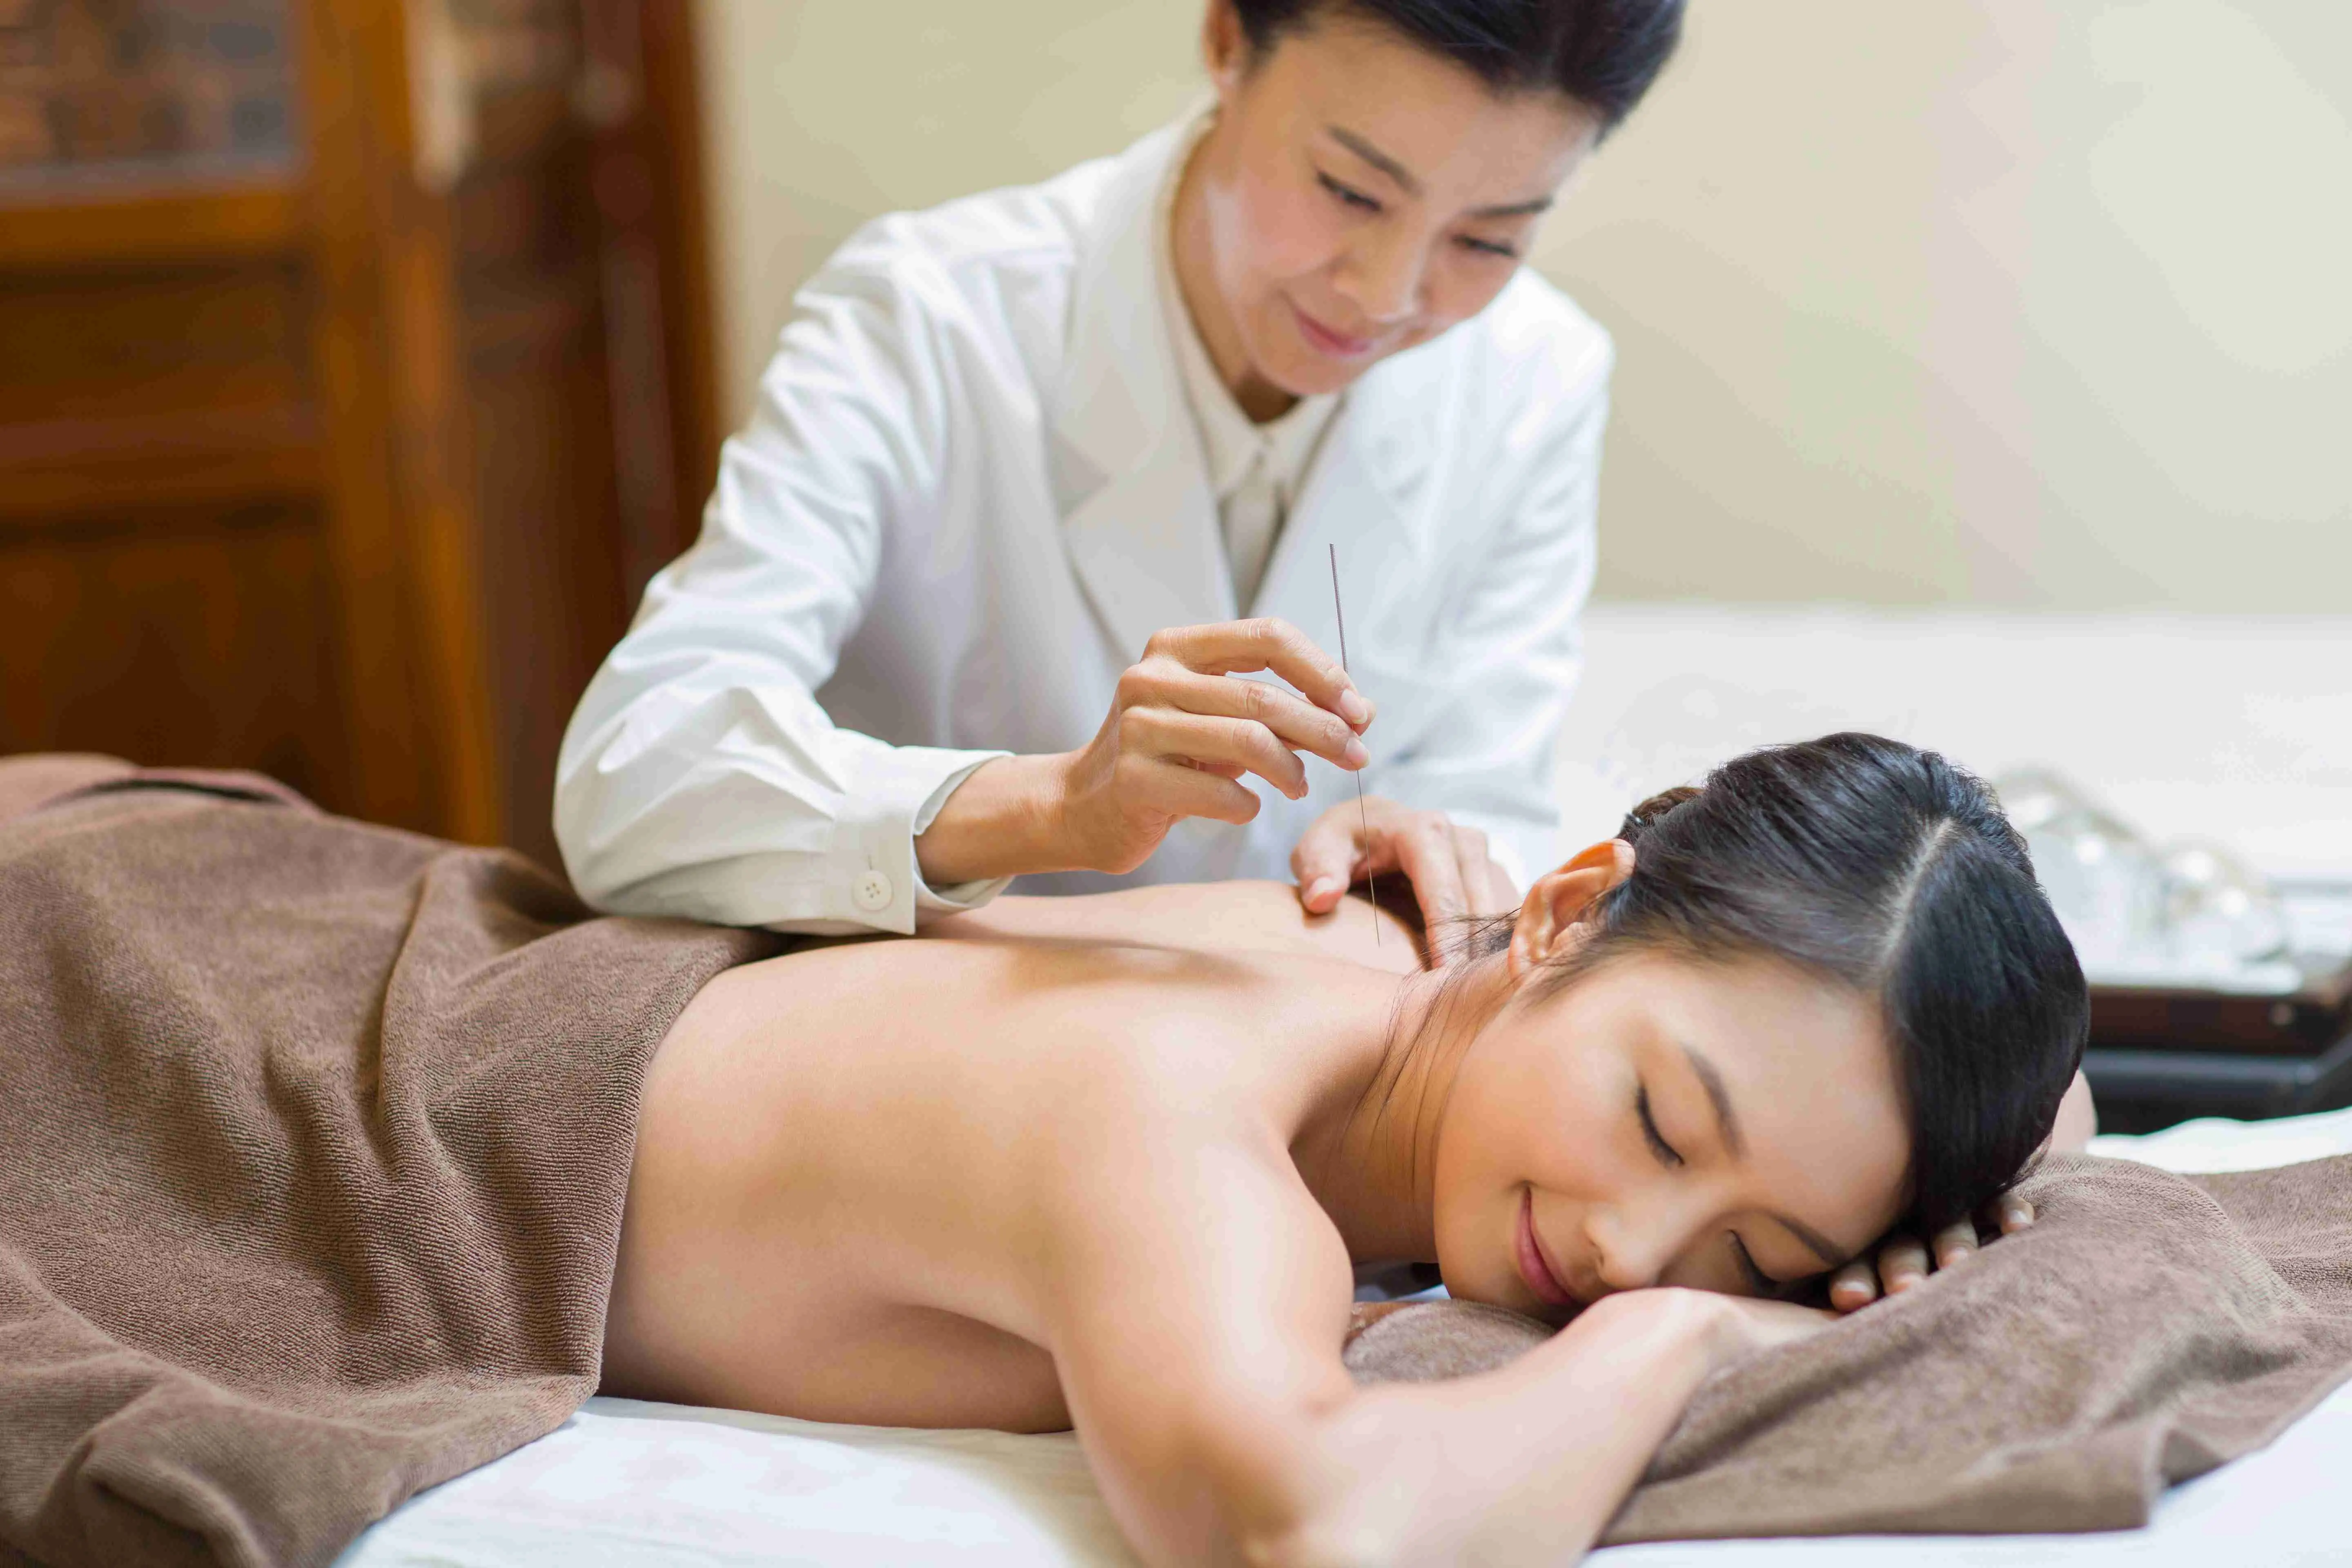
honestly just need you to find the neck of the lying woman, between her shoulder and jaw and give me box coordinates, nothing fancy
[1291,959,1510,1263]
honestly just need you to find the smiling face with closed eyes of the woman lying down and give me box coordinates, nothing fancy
[1437,954,1910,1321]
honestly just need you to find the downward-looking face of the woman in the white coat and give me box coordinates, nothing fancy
[1178,0,1597,411]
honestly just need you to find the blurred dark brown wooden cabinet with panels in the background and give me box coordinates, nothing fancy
[0,0,717,860]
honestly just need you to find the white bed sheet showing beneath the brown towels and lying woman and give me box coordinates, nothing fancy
[339,1109,2352,1568]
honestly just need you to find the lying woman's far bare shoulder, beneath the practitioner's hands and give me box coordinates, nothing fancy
[924,882,1423,973]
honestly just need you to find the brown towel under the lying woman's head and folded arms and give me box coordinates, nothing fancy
[1348,1157,2352,1542]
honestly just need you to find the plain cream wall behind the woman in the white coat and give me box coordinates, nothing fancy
[701,0,2352,611]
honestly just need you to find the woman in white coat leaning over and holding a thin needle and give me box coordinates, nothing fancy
[555,0,1682,933]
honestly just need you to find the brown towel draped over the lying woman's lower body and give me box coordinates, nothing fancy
[0,760,776,1568]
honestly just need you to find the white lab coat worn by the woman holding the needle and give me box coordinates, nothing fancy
[555,125,1611,933]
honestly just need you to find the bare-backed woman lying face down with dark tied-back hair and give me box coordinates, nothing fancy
[604,736,2086,1563]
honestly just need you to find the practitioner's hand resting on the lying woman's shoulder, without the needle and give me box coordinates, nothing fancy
[1291,795,1519,964]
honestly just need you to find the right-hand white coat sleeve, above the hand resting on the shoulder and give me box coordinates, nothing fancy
[1371,350,1609,891]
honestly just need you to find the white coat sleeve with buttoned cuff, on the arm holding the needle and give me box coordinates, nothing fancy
[555,247,1004,935]
